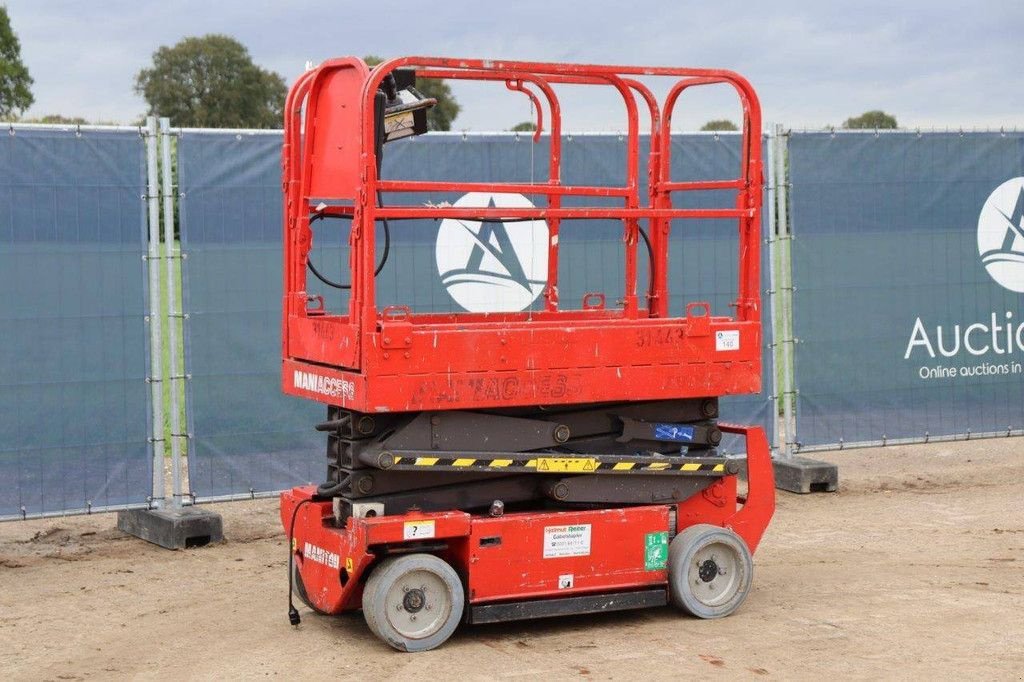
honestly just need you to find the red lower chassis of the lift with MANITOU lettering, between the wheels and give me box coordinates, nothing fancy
[281,425,775,613]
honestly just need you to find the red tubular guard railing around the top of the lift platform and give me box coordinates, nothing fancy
[283,56,762,333]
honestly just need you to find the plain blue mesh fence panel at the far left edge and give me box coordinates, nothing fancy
[0,128,152,518]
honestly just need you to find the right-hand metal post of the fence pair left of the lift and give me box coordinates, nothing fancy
[160,118,187,509]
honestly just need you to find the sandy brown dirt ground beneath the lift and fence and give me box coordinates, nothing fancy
[0,438,1024,680]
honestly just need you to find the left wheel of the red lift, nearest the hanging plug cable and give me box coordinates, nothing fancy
[362,554,465,651]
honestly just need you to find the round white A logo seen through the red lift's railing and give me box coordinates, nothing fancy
[435,191,548,312]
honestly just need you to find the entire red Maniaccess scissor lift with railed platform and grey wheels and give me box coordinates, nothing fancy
[281,57,774,651]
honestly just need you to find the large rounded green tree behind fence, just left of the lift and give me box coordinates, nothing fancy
[135,34,287,128]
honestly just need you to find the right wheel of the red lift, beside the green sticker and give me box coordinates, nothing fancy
[669,523,754,619]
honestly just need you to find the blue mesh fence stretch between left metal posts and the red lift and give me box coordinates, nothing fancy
[178,132,326,498]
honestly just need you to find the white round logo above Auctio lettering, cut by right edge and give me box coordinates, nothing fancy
[978,177,1024,293]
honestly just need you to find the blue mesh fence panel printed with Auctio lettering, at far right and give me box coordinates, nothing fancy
[790,133,1024,447]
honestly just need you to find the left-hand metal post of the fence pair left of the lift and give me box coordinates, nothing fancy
[145,116,165,509]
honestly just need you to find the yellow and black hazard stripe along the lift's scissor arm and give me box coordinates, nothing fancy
[388,453,734,475]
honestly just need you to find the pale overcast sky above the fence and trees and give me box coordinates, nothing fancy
[6,0,1024,130]
